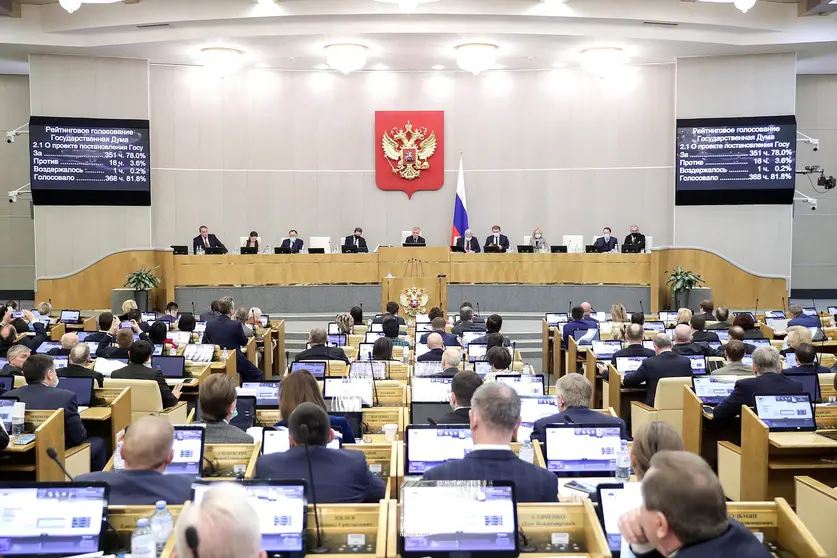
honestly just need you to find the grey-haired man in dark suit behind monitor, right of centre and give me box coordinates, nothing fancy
[531,374,628,444]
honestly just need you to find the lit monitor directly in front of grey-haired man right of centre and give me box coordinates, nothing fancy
[544,424,622,477]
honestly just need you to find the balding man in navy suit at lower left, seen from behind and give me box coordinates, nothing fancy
[75,418,193,506]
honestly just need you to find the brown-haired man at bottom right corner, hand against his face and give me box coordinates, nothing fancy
[619,451,771,558]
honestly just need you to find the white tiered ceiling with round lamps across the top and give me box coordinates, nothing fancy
[0,0,837,73]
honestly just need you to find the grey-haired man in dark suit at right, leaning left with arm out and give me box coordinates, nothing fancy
[712,347,802,420]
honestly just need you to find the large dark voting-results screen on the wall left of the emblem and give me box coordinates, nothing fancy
[29,116,151,205]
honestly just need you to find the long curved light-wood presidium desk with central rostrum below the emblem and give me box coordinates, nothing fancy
[36,246,788,318]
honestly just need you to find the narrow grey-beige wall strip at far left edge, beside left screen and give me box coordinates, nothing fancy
[0,75,35,291]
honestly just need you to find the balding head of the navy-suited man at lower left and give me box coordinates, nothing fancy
[122,415,174,472]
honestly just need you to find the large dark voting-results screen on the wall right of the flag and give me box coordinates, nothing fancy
[675,116,796,205]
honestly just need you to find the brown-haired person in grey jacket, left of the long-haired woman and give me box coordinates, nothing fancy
[198,374,253,444]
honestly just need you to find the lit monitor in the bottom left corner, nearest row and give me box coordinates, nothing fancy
[0,482,109,556]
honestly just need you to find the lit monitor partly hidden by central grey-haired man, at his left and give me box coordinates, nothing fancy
[404,424,474,476]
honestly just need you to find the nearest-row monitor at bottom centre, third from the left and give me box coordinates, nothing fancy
[393,481,520,558]
